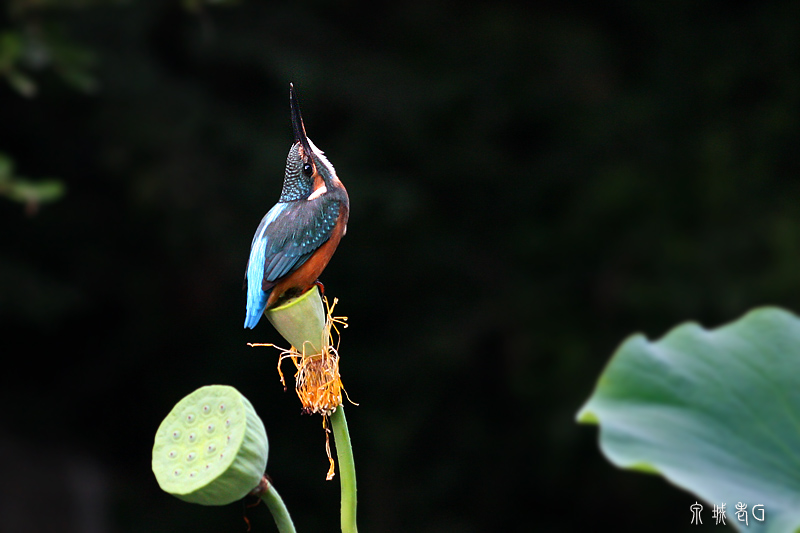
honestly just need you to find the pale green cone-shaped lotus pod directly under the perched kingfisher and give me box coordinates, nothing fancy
[264,285,326,354]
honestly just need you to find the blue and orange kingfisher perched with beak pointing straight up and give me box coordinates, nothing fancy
[244,83,350,329]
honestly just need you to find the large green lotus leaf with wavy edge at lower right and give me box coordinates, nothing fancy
[578,308,800,532]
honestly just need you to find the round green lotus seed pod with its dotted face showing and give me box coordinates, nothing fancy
[153,385,269,505]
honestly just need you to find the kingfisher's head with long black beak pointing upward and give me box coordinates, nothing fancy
[281,84,338,202]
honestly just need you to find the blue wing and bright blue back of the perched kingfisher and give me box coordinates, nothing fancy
[244,197,341,328]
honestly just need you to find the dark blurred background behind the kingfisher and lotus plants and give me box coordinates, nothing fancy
[0,0,800,533]
